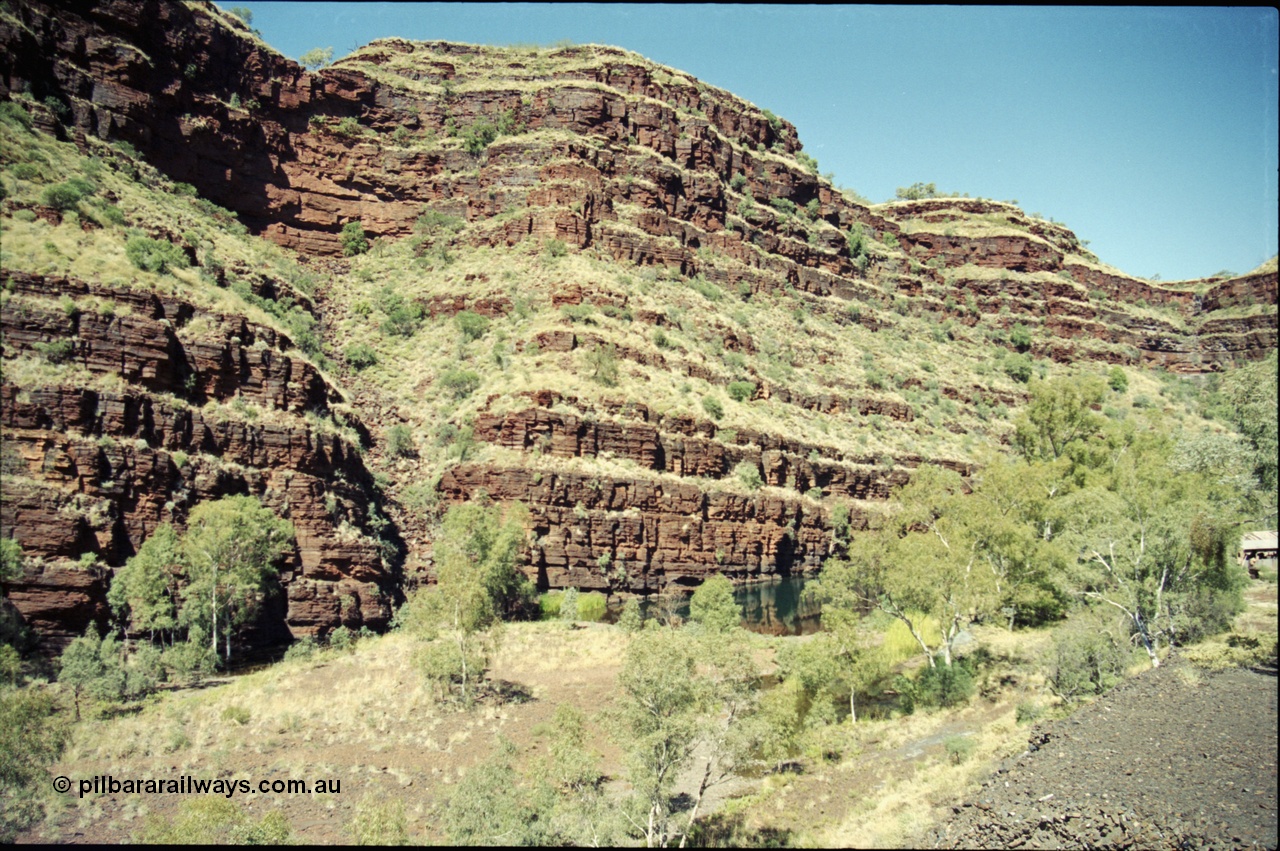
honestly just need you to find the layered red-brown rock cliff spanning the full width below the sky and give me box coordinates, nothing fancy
[0,0,1276,650]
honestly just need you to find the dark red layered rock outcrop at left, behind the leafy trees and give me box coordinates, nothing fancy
[0,270,397,640]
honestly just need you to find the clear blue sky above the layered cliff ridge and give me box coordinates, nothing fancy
[244,0,1280,280]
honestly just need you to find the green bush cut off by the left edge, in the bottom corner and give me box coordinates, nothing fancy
[0,688,70,842]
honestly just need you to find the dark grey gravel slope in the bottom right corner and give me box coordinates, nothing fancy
[916,658,1277,848]
